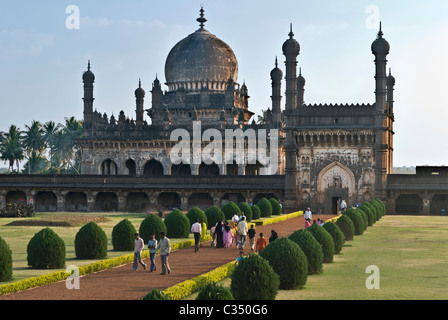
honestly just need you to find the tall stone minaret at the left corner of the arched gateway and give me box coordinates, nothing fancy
[282,24,300,213]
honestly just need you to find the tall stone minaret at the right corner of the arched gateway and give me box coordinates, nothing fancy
[372,23,391,200]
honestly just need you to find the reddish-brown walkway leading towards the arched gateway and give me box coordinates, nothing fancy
[0,215,334,300]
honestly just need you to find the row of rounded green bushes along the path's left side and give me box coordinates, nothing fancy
[0,198,281,282]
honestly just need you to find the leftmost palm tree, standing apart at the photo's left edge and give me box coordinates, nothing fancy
[0,125,24,172]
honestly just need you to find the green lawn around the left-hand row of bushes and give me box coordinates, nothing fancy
[0,212,191,284]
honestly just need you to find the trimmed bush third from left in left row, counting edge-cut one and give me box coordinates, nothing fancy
[75,221,107,259]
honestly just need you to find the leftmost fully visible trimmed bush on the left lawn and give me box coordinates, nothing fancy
[26,228,65,269]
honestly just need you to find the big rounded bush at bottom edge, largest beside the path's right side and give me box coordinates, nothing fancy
[230,252,280,300]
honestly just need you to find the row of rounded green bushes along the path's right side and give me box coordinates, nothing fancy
[145,199,386,300]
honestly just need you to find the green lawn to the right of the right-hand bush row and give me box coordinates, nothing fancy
[182,216,448,300]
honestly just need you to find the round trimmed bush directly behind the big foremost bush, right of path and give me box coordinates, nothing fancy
[259,237,308,290]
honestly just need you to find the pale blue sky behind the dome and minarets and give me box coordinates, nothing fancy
[0,0,448,166]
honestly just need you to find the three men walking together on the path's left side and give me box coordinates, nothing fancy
[132,232,171,275]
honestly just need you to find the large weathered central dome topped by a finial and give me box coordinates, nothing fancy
[165,9,238,91]
